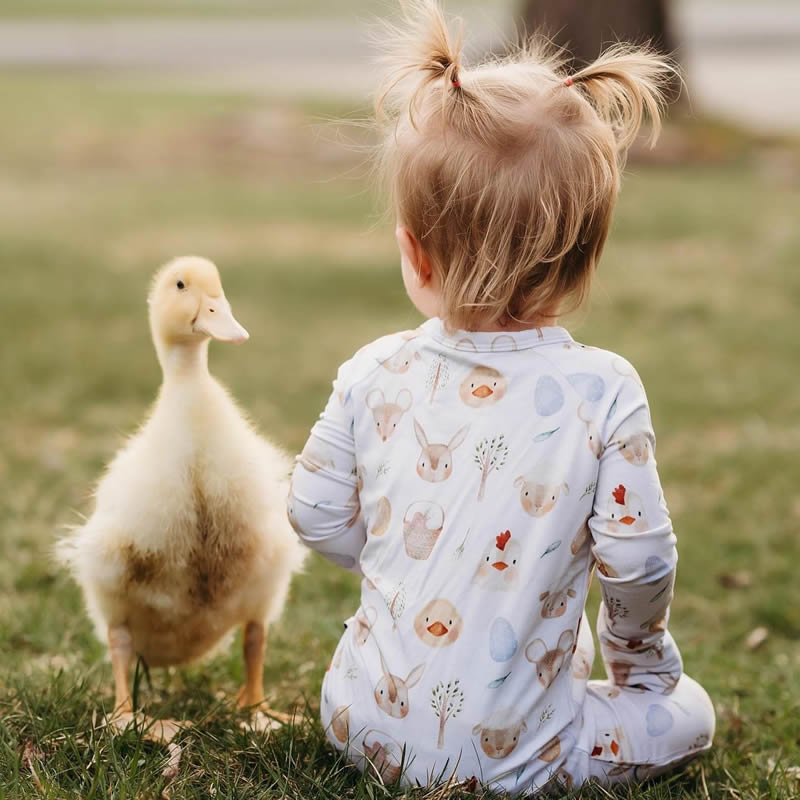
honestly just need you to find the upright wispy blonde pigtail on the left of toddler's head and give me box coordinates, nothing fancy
[376,0,463,124]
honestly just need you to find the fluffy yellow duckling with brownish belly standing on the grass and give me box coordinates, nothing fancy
[56,257,305,742]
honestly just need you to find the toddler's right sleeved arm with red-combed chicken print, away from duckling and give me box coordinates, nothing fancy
[589,359,683,694]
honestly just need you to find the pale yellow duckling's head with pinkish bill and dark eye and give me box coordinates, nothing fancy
[148,256,250,355]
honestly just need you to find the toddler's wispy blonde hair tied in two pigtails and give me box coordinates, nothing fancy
[378,0,674,329]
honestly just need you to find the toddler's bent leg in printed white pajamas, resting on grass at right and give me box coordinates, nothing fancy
[567,675,714,786]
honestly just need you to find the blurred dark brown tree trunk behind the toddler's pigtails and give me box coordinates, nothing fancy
[521,0,675,68]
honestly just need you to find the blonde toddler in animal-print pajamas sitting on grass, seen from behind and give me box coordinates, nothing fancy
[289,0,714,793]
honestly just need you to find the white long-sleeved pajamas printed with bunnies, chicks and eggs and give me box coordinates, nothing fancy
[288,319,713,793]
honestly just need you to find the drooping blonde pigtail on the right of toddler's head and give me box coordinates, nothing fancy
[564,44,677,155]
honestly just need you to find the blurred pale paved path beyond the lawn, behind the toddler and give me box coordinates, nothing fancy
[0,0,800,130]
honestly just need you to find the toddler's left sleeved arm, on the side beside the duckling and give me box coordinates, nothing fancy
[288,361,367,574]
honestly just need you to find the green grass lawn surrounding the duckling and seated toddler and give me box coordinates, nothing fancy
[0,73,800,800]
